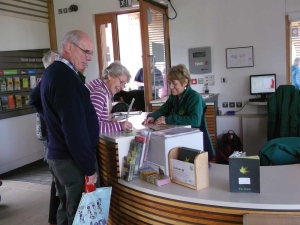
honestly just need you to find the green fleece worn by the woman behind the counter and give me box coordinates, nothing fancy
[148,86,206,128]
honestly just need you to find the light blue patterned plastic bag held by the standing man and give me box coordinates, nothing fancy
[73,187,111,225]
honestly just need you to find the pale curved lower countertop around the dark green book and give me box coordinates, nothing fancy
[119,164,300,211]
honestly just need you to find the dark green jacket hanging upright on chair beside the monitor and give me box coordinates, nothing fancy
[267,85,300,140]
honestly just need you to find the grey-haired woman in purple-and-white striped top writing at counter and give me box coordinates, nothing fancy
[86,61,132,133]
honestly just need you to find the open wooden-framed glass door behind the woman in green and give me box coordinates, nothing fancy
[139,0,170,111]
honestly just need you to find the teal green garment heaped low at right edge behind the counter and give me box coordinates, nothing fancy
[259,137,300,166]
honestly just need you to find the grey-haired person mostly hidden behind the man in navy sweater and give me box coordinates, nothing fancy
[38,50,60,225]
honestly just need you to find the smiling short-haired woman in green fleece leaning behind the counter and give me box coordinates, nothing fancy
[143,64,215,160]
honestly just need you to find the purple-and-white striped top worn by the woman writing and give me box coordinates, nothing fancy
[85,78,121,133]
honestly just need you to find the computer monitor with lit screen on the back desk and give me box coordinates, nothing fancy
[250,74,276,101]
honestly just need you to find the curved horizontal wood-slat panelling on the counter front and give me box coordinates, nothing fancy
[97,139,300,225]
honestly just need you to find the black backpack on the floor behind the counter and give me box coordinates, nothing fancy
[216,130,242,164]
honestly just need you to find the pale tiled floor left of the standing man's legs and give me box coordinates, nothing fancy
[0,180,50,225]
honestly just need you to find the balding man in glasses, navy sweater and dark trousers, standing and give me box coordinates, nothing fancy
[30,30,99,225]
